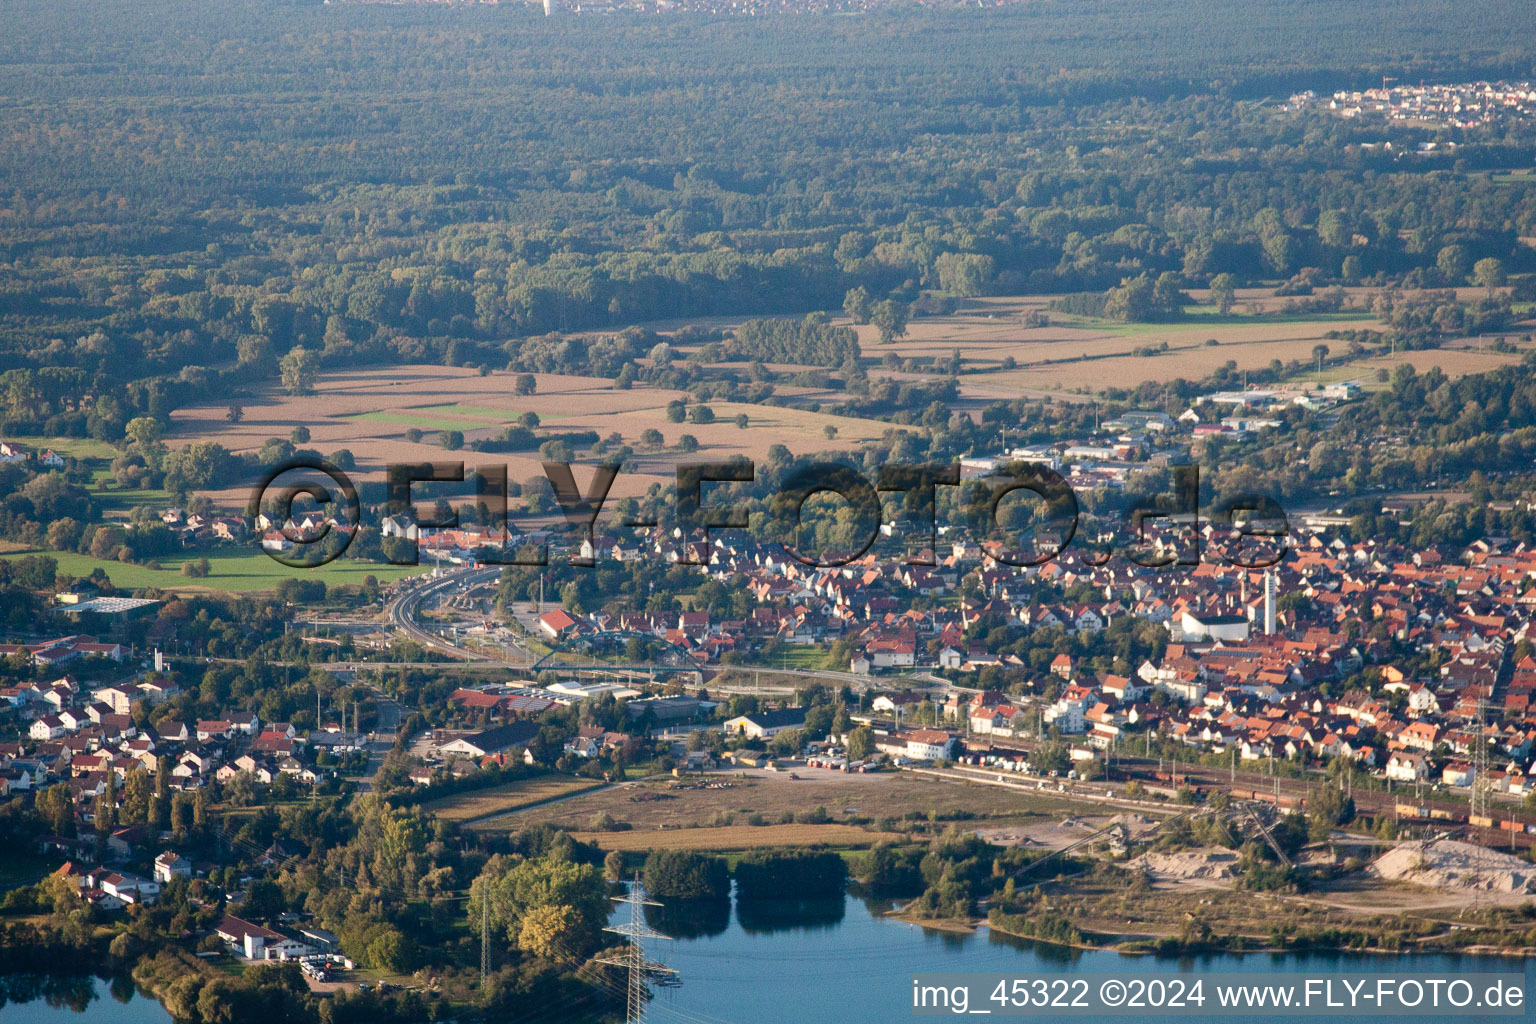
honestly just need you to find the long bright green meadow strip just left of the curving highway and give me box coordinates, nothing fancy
[0,548,421,593]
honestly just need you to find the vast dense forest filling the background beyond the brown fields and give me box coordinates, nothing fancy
[0,0,1536,451]
